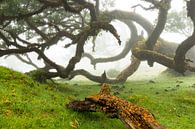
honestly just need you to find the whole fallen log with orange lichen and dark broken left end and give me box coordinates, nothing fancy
[67,84,167,129]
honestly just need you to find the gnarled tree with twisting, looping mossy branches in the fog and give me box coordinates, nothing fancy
[0,0,194,83]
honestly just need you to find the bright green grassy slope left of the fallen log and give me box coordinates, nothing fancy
[0,67,124,129]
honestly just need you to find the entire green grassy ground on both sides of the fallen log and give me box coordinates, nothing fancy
[0,67,195,129]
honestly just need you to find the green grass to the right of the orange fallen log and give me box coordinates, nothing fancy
[121,77,195,129]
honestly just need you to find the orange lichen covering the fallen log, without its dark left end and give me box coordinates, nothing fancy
[86,84,165,129]
